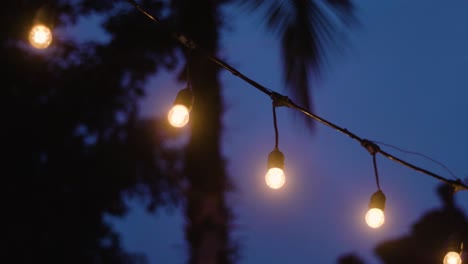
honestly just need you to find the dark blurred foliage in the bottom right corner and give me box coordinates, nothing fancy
[339,185,468,264]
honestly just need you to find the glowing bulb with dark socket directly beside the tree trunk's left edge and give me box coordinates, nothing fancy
[167,88,193,128]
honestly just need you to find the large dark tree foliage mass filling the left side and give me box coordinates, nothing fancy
[0,1,183,263]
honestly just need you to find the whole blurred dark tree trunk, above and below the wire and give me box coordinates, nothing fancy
[176,0,233,264]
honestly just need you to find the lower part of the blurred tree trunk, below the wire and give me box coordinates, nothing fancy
[185,53,231,264]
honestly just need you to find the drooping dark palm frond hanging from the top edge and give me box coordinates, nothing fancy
[240,0,356,128]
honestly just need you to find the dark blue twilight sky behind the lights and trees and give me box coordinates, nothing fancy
[72,0,468,264]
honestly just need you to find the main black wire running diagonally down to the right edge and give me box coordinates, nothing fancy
[123,0,468,191]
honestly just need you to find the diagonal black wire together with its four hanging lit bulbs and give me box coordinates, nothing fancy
[87,0,468,258]
